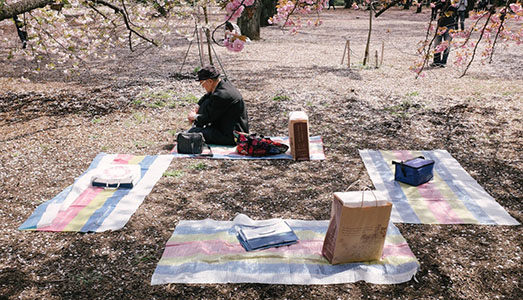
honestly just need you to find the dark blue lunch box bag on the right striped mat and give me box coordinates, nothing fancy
[392,156,434,186]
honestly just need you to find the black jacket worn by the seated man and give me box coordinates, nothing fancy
[195,79,249,145]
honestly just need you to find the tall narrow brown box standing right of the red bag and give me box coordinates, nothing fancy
[289,111,310,160]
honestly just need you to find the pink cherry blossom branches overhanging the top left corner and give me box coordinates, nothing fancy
[0,0,169,72]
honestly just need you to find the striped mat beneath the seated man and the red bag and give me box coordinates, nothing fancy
[171,136,325,160]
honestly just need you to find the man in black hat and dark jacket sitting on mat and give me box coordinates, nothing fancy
[187,66,249,145]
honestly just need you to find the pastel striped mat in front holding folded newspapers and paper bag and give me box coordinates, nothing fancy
[151,215,419,285]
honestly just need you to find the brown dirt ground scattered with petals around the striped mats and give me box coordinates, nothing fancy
[0,8,523,300]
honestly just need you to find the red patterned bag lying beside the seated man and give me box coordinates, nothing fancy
[234,131,289,156]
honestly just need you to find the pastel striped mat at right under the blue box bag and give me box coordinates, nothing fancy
[359,150,519,225]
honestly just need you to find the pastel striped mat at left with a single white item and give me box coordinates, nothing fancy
[18,153,172,232]
